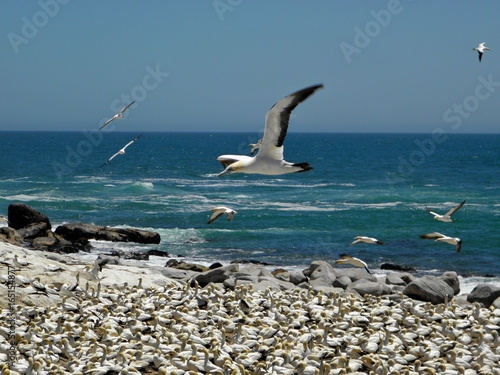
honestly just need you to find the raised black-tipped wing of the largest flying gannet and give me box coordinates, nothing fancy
[256,85,323,160]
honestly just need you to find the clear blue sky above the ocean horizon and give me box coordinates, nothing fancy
[0,0,500,133]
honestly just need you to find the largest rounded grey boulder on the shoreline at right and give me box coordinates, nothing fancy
[403,275,454,304]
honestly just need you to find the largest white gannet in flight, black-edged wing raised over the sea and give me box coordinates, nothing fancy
[217,85,323,177]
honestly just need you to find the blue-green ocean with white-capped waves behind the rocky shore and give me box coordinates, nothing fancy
[0,131,500,294]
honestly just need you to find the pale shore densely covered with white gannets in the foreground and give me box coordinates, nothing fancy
[0,243,500,375]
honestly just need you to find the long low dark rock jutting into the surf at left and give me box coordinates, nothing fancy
[55,223,161,244]
